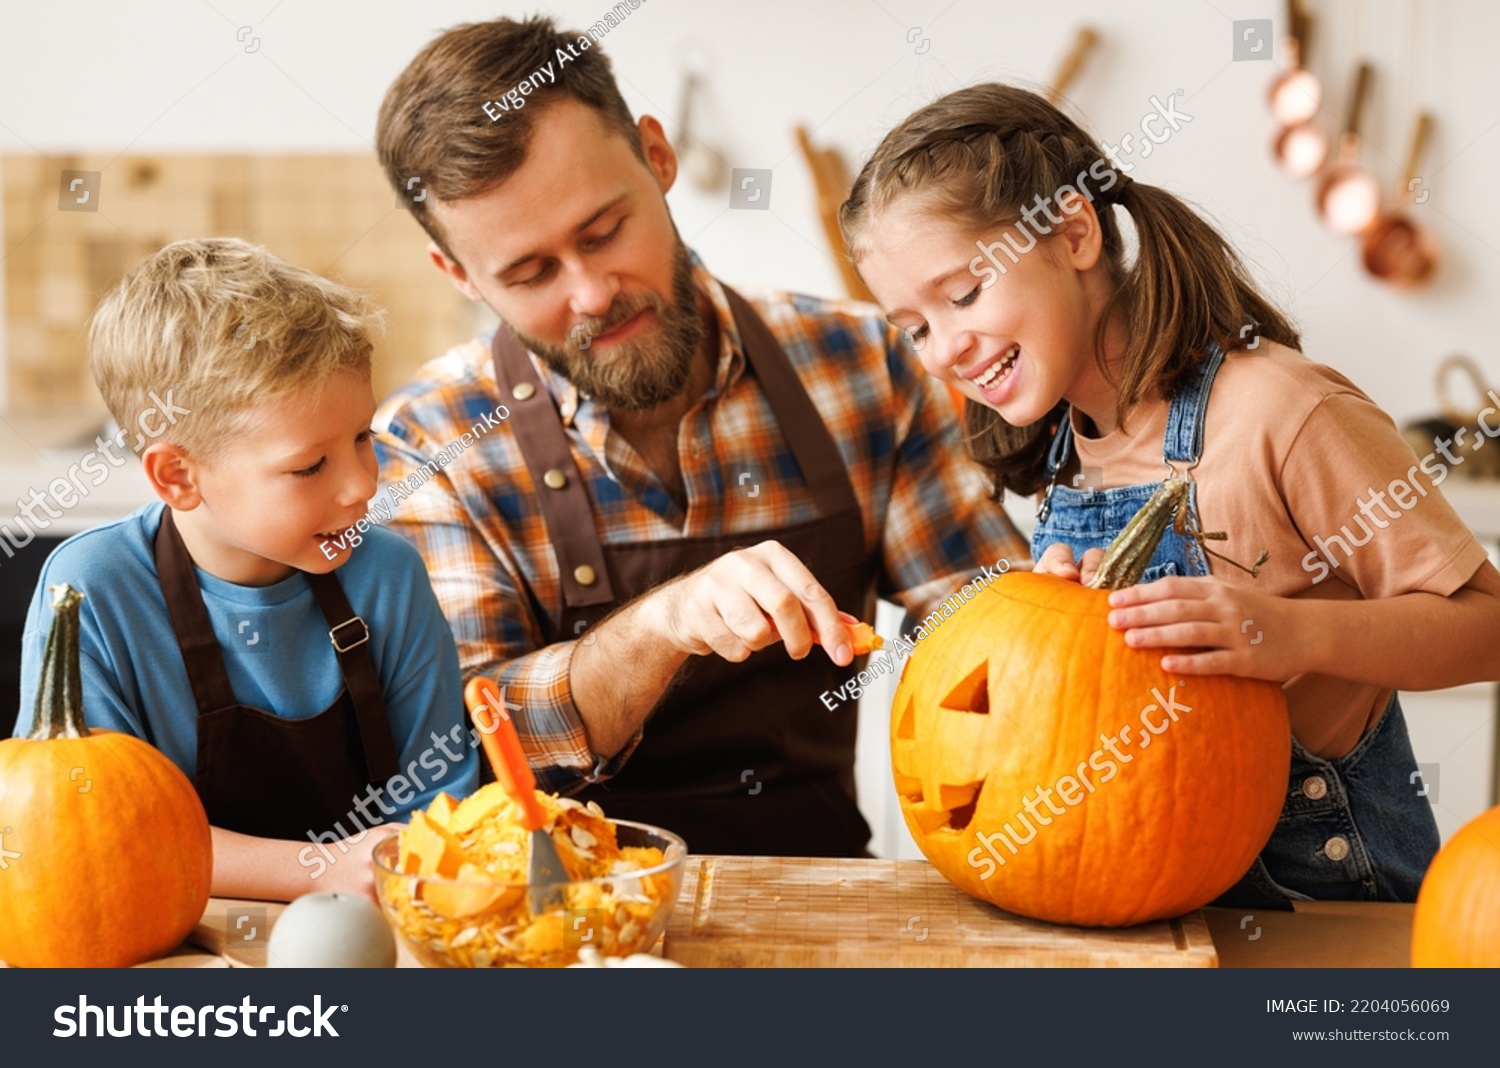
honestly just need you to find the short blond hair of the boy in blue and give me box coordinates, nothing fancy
[89,237,380,459]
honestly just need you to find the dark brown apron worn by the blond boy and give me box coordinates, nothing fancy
[156,509,399,839]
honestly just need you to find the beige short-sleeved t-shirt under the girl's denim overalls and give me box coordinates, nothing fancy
[1059,341,1487,759]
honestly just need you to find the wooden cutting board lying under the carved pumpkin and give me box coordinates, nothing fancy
[663,857,1218,968]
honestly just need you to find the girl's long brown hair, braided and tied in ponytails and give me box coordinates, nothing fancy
[839,84,1299,500]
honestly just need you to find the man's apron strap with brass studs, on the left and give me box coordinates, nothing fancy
[491,323,615,608]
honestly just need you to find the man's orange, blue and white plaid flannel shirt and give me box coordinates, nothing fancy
[375,255,1029,792]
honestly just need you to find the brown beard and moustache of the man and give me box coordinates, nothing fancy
[515,240,704,411]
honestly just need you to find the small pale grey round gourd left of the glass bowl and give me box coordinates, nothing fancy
[266,894,396,968]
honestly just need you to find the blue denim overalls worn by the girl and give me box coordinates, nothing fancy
[1032,345,1439,909]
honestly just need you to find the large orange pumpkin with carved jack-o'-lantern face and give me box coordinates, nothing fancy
[891,483,1292,927]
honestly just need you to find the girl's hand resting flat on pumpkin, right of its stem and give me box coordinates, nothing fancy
[1109,576,1310,683]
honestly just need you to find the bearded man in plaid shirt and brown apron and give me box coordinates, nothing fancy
[377,12,1026,857]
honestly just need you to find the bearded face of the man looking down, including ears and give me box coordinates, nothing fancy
[432,101,702,411]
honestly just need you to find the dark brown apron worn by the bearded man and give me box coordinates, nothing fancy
[494,287,875,857]
